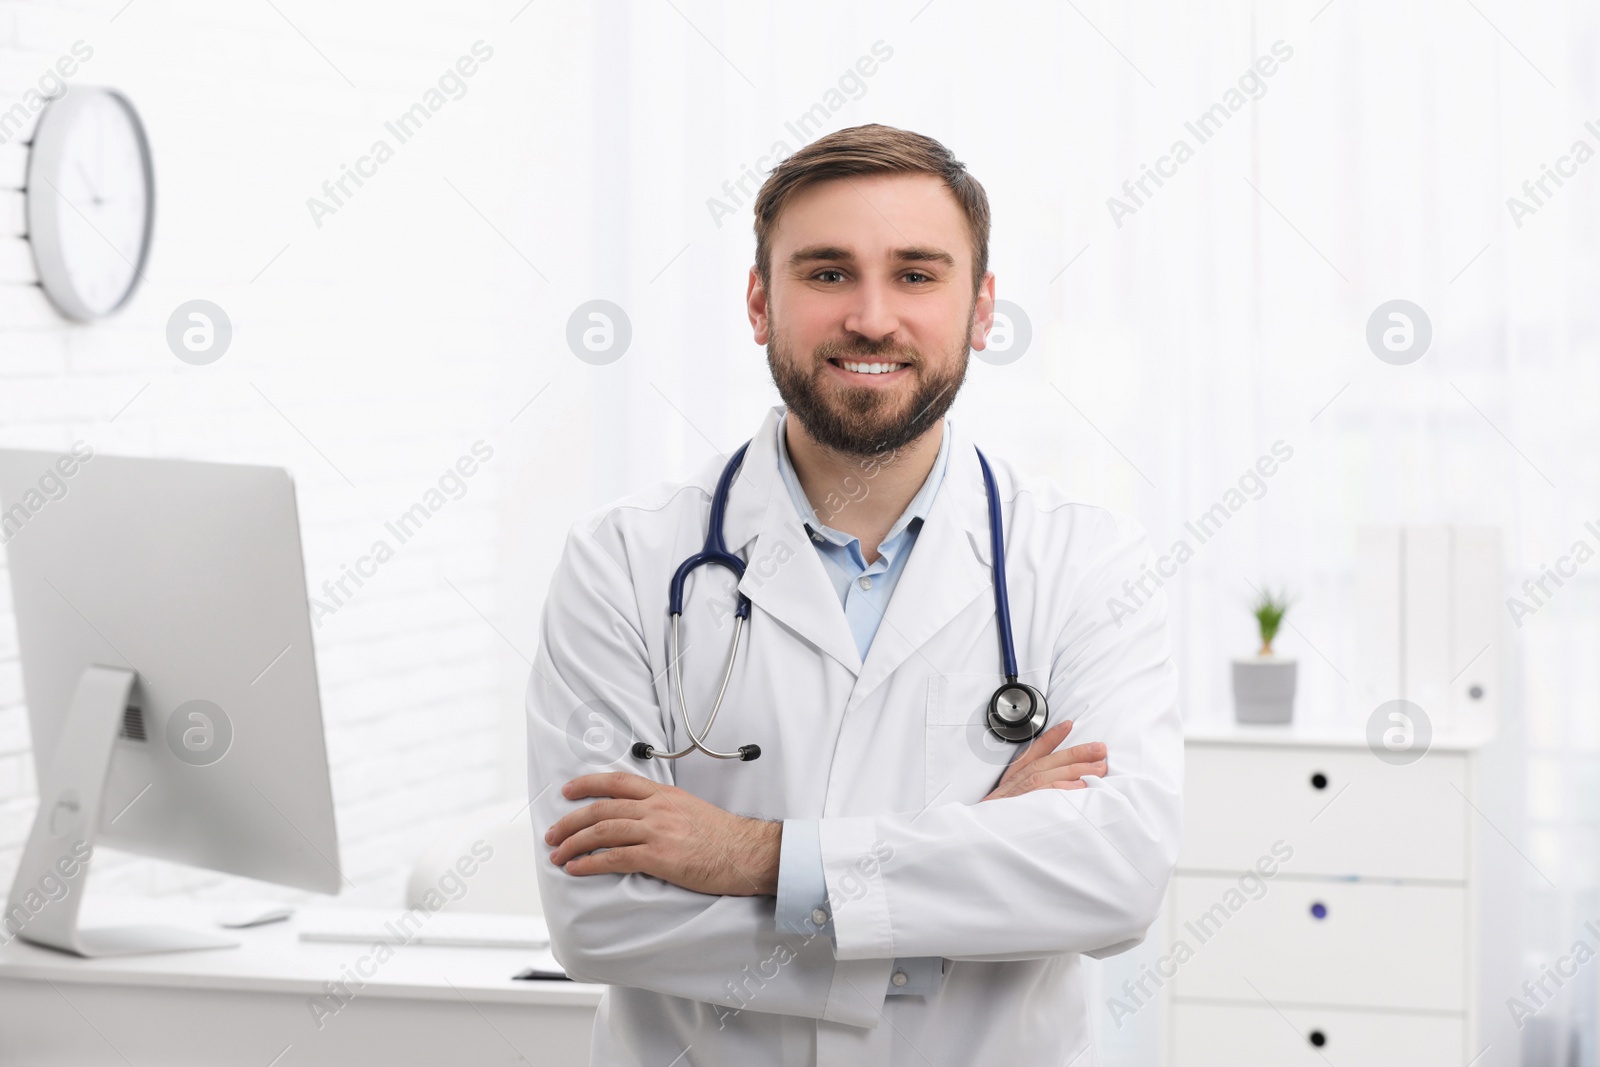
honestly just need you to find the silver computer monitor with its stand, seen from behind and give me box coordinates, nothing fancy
[0,442,342,955]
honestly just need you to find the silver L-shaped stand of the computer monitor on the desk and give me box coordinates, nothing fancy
[0,665,238,957]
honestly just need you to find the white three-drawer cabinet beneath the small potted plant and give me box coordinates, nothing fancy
[1152,726,1491,1067]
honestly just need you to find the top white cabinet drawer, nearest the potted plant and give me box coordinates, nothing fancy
[1178,744,1472,881]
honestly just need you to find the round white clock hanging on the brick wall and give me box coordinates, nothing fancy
[27,86,155,322]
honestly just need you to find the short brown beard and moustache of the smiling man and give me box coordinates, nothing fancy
[766,304,978,458]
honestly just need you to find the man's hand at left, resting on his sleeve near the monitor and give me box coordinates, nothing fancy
[544,771,782,896]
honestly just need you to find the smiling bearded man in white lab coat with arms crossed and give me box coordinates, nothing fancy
[528,125,1182,1067]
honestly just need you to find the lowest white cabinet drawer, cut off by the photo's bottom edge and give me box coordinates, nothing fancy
[1171,1000,1467,1067]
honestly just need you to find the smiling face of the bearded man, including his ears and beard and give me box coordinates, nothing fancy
[749,173,994,456]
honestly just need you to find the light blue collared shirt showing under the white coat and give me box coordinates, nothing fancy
[778,413,950,997]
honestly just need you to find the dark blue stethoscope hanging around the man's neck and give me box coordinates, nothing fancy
[632,442,1050,760]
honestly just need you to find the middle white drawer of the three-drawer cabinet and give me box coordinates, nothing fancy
[1168,875,1467,1011]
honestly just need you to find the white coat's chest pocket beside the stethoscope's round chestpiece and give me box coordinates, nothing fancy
[923,672,1048,808]
